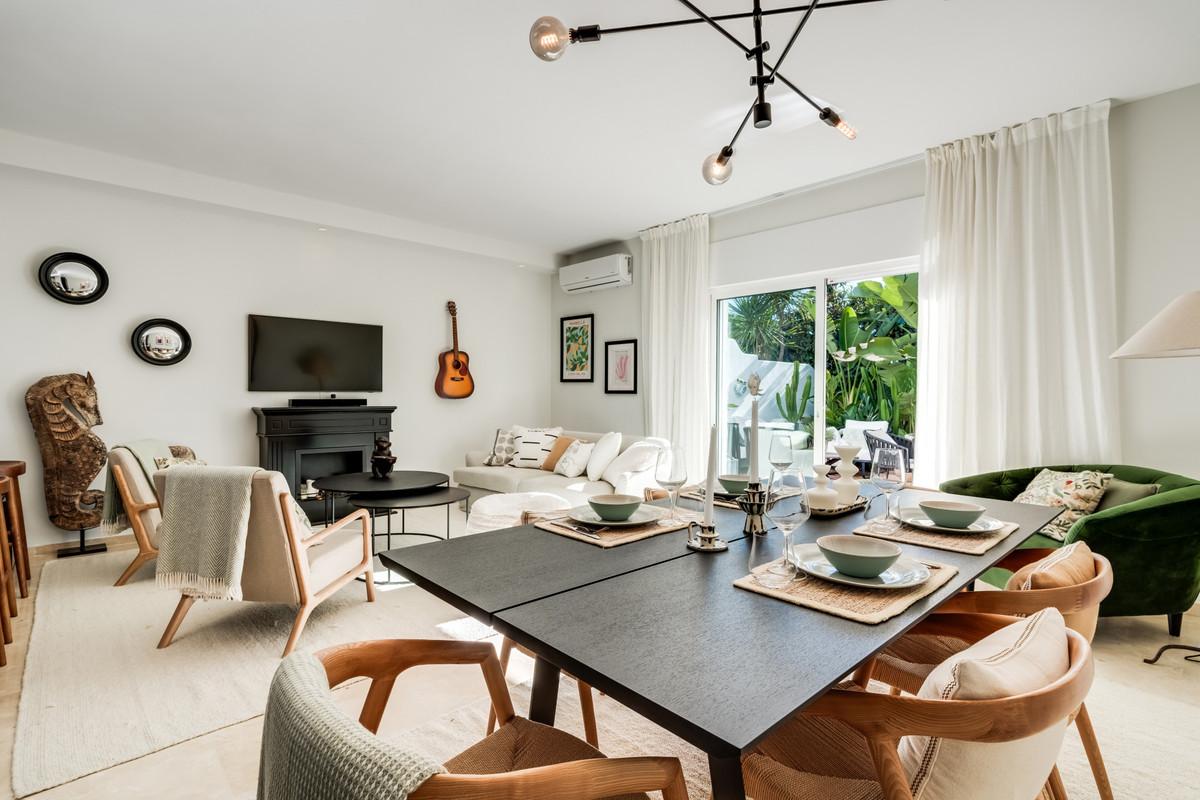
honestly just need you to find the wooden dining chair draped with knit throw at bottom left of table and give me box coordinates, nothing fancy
[258,639,688,800]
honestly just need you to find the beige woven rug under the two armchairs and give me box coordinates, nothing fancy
[12,551,462,798]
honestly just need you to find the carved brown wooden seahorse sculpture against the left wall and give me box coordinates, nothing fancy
[25,372,108,530]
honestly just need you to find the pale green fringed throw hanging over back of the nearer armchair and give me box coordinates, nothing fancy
[155,467,259,600]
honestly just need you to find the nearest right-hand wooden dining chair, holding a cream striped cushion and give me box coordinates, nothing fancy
[743,609,1093,800]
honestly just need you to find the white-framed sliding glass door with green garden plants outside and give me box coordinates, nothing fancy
[714,259,918,475]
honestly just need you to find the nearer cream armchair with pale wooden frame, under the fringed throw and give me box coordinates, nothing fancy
[155,470,376,656]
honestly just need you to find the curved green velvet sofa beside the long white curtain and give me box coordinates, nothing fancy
[940,464,1200,636]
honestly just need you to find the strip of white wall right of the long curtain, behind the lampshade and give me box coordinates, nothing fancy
[1110,85,1200,476]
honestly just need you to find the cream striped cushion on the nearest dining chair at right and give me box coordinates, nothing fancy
[900,608,1070,800]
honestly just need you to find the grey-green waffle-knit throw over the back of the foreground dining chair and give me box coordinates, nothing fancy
[258,652,445,800]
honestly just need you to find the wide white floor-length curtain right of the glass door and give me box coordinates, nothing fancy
[917,102,1120,485]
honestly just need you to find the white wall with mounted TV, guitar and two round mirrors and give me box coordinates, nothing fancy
[0,167,556,545]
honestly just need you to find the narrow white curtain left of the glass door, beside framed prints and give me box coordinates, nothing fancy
[637,215,713,481]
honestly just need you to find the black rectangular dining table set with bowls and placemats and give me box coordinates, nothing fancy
[380,489,1061,800]
